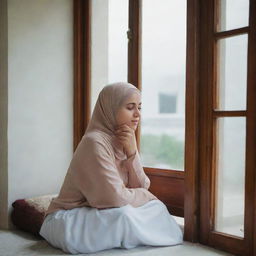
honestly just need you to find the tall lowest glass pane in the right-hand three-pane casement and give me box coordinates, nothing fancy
[215,117,246,237]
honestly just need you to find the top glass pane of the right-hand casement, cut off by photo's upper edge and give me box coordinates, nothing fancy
[217,0,249,31]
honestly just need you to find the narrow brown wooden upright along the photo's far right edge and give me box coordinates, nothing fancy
[245,0,256,256]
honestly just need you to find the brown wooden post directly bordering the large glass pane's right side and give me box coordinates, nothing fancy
[184,0,199,242]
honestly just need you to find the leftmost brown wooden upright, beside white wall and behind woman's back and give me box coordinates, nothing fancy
[73,0,91,151]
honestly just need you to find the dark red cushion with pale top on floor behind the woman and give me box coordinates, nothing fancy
[11,195,57,236]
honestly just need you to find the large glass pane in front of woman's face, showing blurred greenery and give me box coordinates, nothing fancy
[141,0,186,170]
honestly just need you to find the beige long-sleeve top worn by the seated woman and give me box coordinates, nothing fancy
[46,132,157,215]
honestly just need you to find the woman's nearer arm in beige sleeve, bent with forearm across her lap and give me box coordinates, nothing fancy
[72,138,157,208]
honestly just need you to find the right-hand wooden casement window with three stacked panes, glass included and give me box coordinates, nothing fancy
[200,0,256,255]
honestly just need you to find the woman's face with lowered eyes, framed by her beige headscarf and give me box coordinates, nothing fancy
[116,93,141,131]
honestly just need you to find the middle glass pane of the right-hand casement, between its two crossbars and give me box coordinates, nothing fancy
[218,35,248,110]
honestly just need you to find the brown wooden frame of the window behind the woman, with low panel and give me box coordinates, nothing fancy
[74,0,199,242]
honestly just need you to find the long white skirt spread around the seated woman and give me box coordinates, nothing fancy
[40,200,183,254]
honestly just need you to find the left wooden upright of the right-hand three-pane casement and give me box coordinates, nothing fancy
[199,0,213,244]
